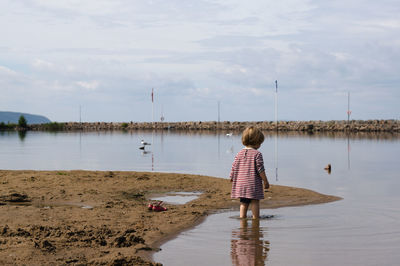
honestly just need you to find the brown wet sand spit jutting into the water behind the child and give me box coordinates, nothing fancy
[0,170,340,265]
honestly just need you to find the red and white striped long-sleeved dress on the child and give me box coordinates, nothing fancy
[230,148,265,199]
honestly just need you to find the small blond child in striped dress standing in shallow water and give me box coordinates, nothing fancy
[230,126,269,219]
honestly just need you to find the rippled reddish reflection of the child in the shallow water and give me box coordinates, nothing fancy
[231,219,269,266]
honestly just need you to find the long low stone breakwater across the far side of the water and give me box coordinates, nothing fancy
[27,120,400,133]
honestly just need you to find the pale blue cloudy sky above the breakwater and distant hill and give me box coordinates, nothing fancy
[0,0,400,122]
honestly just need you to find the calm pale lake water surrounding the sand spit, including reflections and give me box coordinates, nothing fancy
[0,131,400,265]
